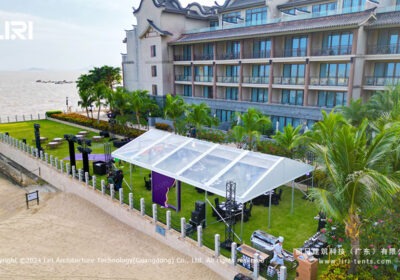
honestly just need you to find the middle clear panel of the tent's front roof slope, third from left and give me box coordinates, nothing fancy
[155,141,214,173]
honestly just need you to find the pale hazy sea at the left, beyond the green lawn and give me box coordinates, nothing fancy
[0,70,81,122]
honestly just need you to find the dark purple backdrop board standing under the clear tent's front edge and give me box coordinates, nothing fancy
[151,171,180,211]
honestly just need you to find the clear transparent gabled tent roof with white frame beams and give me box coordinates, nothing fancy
[112,129,314,203]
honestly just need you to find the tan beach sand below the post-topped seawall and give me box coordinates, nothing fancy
[0,178,225,280]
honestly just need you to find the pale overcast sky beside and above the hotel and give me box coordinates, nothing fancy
[0,0,224,70]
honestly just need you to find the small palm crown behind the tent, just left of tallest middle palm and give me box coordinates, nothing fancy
[186,102,218,129]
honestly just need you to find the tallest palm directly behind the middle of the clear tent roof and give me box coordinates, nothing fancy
[233,108,271,150]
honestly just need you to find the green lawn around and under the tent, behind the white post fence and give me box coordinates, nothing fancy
[0,120,324,279]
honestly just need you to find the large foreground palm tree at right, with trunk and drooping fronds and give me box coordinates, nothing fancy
[310,117,400,273]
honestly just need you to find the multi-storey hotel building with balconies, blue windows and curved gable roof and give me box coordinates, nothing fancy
[122,0,400,129]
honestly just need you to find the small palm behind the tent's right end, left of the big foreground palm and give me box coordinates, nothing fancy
[272,124,304,158]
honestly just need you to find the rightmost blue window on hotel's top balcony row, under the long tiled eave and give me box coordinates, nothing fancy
[322,32,353,55]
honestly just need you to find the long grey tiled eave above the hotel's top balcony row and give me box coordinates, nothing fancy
[172,9,373,44]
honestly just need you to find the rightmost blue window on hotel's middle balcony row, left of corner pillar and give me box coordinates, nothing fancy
[319,63,350,86]
